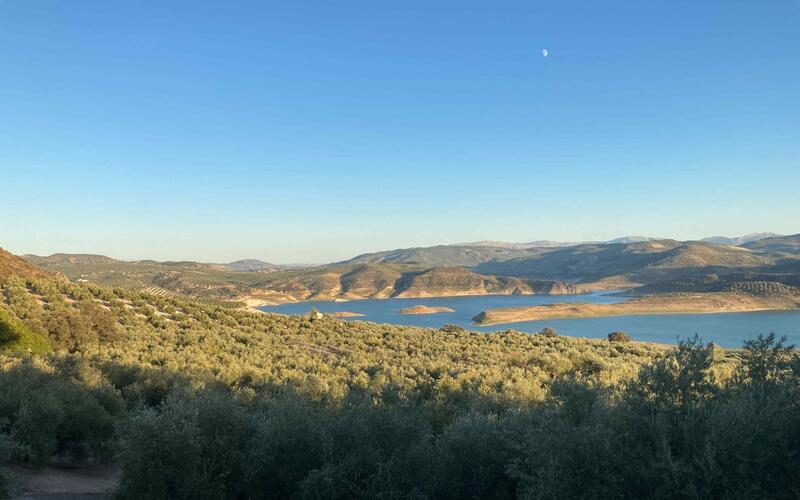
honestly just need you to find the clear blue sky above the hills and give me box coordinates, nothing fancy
[0,0,800,262]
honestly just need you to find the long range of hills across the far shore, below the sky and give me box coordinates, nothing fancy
[14,233,800,303]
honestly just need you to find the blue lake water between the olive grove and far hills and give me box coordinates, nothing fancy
[260,292,800,347]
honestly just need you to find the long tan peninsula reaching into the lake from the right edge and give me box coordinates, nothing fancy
[472,287,800,325]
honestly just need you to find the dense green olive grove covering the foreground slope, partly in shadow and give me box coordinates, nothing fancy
[0,277,800,499]
